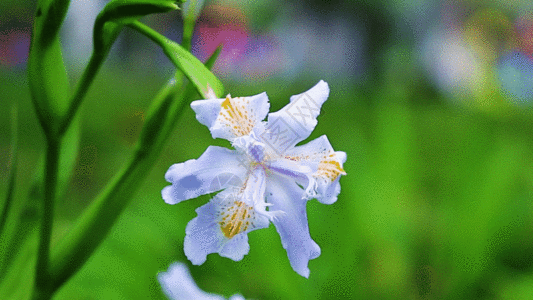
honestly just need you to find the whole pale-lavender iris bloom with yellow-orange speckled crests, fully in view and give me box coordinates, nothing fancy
[162,81,346,277]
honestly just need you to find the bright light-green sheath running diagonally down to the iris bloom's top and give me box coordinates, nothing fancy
[129,21,224,98]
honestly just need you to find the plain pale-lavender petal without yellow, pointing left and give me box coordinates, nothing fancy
[161,146,246,204]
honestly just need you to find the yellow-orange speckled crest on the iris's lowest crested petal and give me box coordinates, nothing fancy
[219,201,255,239]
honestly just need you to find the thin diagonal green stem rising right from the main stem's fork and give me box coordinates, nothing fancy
[58,51,107,136]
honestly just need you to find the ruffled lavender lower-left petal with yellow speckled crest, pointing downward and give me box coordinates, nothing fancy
[184,189,269,265]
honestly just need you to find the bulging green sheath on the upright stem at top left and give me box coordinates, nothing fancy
[28,0,70,137]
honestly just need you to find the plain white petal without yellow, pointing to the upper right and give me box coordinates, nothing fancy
[261,80,329,154]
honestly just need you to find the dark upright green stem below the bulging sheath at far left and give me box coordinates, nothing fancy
[34,139,60,299]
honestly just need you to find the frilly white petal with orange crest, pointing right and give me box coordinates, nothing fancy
[281,135,346,204]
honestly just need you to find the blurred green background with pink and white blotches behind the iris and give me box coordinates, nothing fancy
[0,0,533,299]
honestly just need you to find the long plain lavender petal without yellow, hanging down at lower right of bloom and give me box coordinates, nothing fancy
[266,175,320,278]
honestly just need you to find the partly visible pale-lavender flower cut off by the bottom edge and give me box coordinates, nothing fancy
[157,262,244,300]
